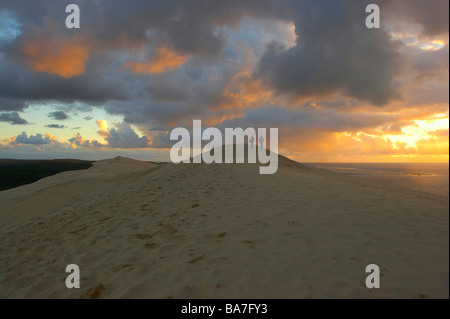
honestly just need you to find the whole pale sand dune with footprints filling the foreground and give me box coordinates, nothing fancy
[0,157,449,298]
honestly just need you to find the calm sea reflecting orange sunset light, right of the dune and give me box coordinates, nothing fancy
[310,163,449,198]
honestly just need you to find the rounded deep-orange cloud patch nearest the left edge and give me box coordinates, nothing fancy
[23,37,89,78]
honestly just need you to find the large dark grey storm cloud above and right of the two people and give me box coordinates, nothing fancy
[257,0,402,105]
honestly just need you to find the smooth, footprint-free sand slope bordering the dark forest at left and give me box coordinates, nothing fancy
[0,156,158,226]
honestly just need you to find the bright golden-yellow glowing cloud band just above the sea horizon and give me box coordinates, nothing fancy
[279,115,449,163]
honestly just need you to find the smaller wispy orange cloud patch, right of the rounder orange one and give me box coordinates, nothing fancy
[124,47,189,74]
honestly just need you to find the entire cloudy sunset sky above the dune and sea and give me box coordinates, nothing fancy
[0,0,449,163]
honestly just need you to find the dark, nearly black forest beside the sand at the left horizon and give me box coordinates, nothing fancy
[0,159,94,191]
